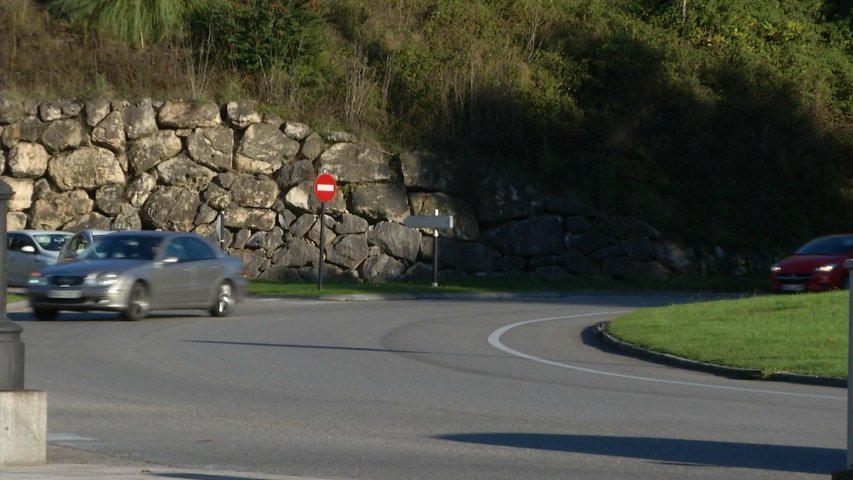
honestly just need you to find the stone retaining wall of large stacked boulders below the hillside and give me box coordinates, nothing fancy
[0,98,692,282]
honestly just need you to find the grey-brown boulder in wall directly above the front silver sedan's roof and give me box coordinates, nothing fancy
[139,186,201,232]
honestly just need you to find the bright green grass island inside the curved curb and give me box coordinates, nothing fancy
[608,292,849,377]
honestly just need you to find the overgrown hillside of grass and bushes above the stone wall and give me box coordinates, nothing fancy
[0,0,853,264]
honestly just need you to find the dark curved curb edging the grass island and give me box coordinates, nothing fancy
[593,322,847,388]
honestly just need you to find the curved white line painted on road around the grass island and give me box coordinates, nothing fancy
[489,310,847,400]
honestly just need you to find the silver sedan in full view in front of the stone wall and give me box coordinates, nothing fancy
[27,231,248,320]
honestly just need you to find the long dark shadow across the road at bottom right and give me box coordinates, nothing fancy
[434,432,845,475]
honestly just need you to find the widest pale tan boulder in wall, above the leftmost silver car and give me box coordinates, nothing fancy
[47,147,125,190]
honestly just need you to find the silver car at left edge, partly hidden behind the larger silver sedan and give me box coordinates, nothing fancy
[6,230,71,287]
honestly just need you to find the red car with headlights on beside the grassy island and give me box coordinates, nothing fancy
[770,233,853,292]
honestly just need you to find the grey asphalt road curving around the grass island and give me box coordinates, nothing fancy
[8,295,847,480]
